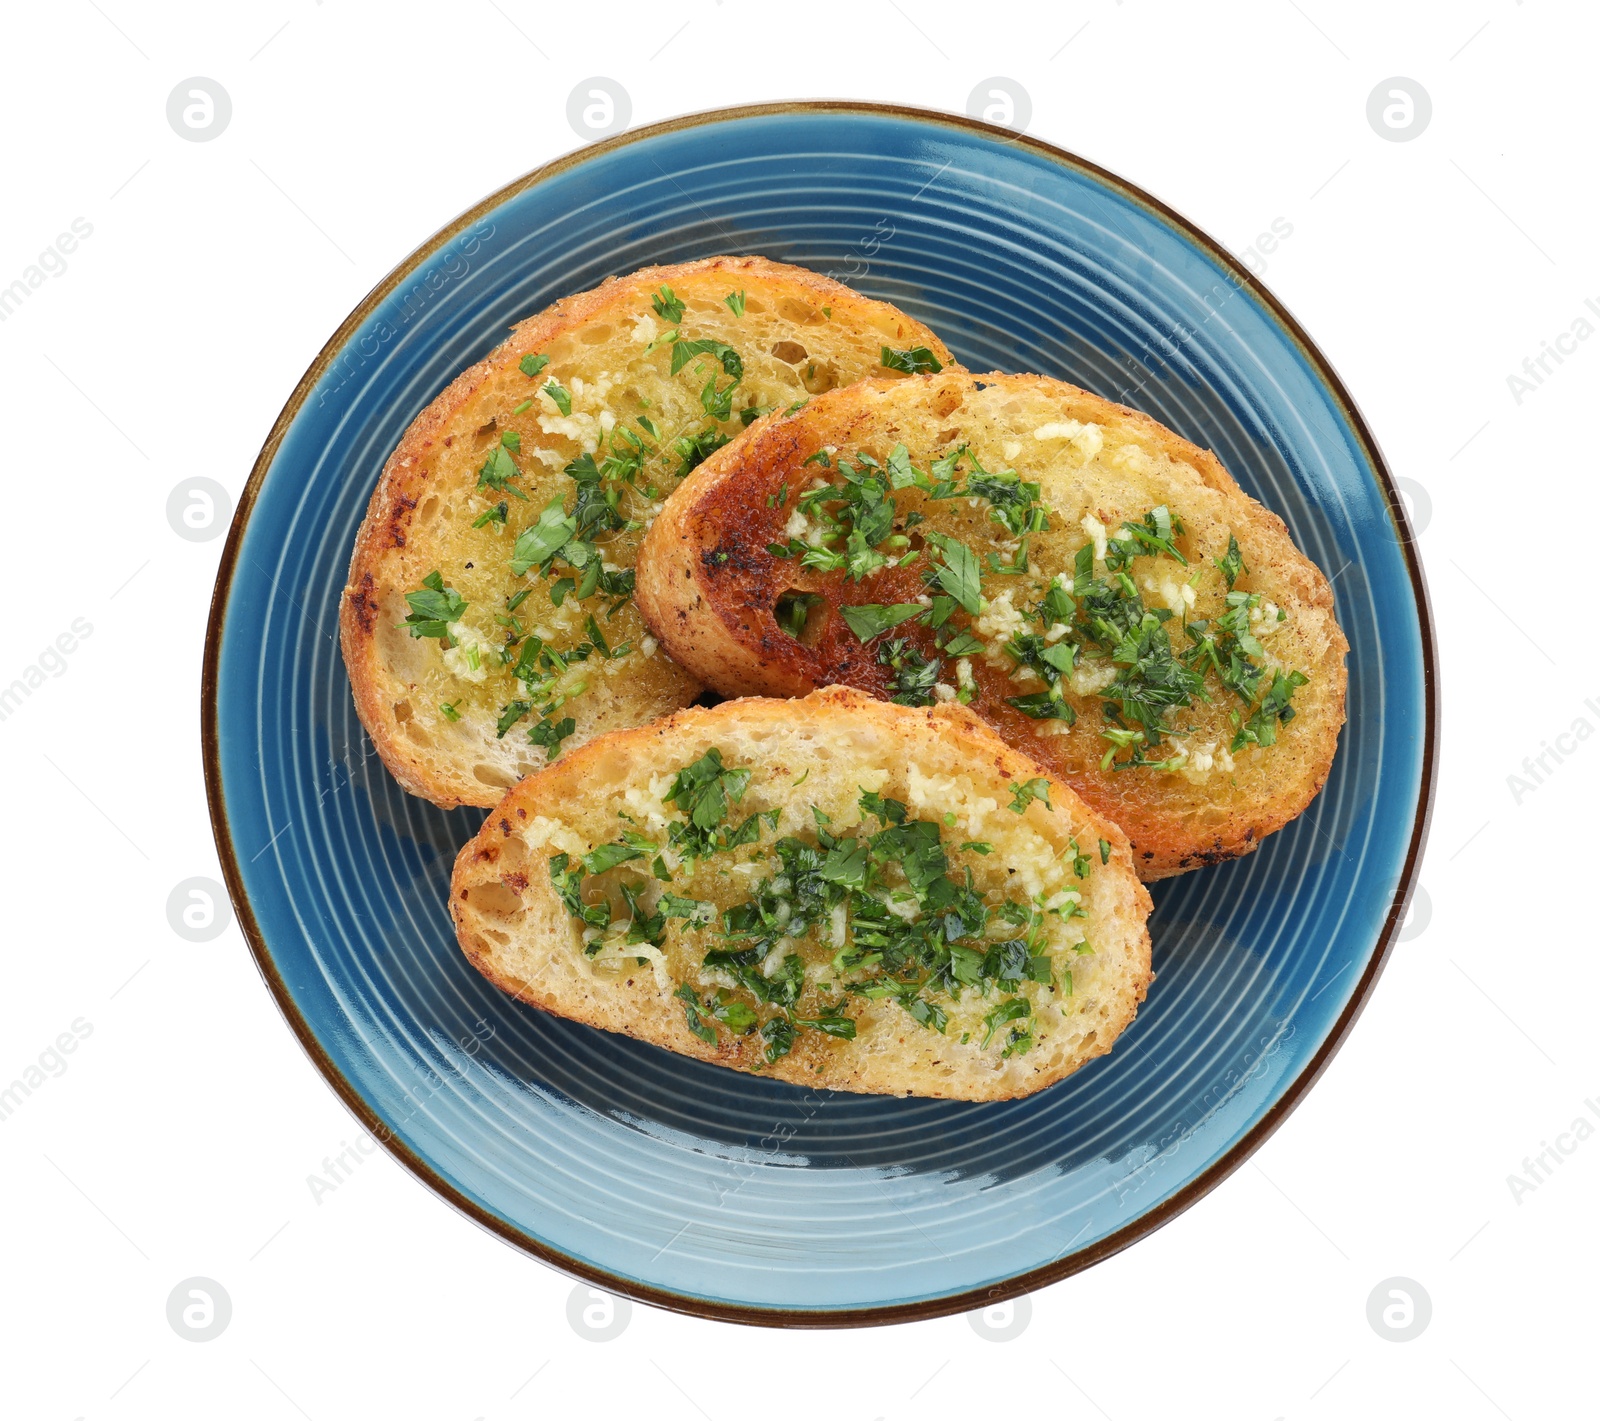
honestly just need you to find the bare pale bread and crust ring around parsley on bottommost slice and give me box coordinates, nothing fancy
[450,686,1150,1101]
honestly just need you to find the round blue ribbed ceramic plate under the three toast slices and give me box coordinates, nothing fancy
[205,104,1434,1325]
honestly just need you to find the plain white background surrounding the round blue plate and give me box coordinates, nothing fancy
[0,0,1600,1421]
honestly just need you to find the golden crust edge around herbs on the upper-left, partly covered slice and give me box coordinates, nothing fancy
[339,256,950,808]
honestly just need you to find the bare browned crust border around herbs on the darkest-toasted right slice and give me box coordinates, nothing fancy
[637,373,1347,880]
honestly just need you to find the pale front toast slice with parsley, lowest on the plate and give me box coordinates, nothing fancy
[450,688,1150,1101]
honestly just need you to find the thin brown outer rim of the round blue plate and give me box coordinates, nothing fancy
[200,99,1438,1328]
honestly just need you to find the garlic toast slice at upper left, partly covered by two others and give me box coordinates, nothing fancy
[339,256,950,808]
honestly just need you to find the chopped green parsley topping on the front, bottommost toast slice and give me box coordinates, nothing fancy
[550,747,1083,1066]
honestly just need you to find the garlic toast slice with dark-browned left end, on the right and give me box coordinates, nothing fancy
[637,373,1347,880]
